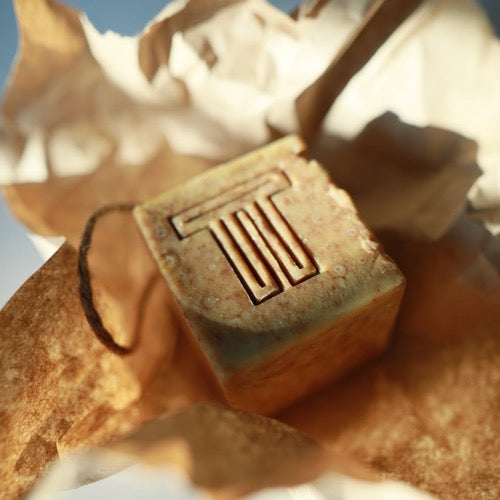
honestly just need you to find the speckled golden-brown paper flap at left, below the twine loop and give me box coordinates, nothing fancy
[0,245,140,497]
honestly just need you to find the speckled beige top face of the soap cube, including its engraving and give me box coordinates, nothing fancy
[135,136,404,376]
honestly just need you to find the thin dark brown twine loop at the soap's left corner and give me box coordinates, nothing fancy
[78,203,150,356]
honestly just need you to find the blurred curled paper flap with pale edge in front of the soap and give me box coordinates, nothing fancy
[32,403,430,500]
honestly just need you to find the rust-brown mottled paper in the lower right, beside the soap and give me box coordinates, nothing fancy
[281,224,500,498]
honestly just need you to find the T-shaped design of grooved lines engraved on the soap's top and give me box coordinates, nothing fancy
[170,170,318,305]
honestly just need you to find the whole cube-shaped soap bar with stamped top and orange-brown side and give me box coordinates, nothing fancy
[135,136,404,413]
